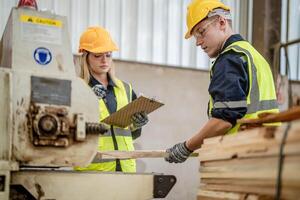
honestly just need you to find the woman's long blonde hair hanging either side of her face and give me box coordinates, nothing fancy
[79,51,116,84]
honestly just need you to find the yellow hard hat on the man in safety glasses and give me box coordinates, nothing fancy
[185,0,230,39]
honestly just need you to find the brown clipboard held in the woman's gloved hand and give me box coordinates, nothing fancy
[101,96,164,128]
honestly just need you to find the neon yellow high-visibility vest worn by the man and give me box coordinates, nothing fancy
[208,41,280,134]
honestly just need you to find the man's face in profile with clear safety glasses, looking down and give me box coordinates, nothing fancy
[192,16,224,58]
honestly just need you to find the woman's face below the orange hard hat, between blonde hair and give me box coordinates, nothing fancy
[87,52,112,75]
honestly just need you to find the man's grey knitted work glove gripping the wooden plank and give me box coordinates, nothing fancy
[165,142,193,163]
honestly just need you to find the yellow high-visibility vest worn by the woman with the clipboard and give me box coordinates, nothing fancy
[75,79,136,172]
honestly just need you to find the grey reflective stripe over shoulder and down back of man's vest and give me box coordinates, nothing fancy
[224,45,278,114]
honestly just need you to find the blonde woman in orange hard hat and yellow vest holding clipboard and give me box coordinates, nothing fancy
[76,27,148,172]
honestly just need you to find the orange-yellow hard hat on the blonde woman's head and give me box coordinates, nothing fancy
[79,27,119,53]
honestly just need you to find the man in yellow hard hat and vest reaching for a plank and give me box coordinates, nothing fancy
[165,0,279,163]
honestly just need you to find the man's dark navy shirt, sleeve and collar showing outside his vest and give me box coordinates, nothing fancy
[208,34,249,126]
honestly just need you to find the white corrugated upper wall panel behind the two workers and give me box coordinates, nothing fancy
[0,0,248,69]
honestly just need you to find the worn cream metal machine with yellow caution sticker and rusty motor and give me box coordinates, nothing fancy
[0,5,176,200]
